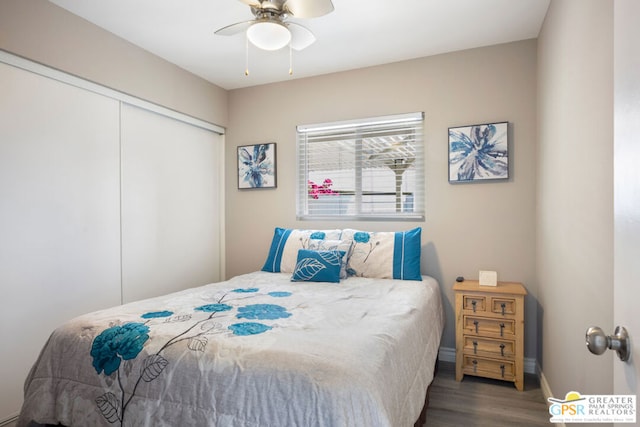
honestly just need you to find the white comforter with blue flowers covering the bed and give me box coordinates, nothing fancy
[18,272,443,427]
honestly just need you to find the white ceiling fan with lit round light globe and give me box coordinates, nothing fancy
[215,0,333,50]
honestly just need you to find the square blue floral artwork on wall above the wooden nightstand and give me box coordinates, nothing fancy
[449,122,509,182]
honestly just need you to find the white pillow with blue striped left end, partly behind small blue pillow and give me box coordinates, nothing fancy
[262,227,342,273]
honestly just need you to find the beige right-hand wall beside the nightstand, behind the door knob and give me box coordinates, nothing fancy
[536,0,614,397]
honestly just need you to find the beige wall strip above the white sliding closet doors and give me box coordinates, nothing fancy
[0,0,227,126]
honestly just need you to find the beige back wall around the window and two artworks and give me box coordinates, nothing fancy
[226,40,537,357]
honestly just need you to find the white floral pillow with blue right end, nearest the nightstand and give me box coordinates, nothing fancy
[342,227,422,280]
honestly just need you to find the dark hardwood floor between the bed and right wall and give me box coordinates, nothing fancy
[425,362,551,427]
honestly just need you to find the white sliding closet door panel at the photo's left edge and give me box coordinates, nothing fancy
[0,63,120,422]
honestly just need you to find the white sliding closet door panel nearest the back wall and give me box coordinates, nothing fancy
[121,104,222,302]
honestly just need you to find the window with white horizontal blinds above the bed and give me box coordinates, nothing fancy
[297,112,424,220]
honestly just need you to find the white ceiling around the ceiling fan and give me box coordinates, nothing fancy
[50,0,550,89]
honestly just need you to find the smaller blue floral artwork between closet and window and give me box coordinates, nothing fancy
[238,142,277,189]
